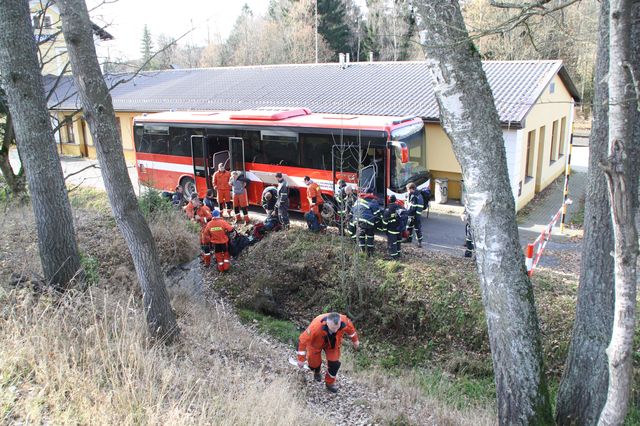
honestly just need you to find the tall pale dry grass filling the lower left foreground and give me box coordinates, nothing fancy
[0,288,328,425]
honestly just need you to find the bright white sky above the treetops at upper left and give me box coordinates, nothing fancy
[87,0,269,60]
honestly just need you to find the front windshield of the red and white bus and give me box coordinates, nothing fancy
[390,123,430,193]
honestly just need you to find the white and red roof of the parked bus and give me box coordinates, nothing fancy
[134,108,422,131]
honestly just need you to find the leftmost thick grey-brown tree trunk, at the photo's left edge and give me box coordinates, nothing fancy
[0,0,80,286]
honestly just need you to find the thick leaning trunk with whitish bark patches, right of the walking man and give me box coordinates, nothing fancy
[418,0,553,425]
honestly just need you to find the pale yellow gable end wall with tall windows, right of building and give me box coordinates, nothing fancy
[517,75,573,205]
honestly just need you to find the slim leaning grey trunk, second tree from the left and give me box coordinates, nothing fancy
[58,0,178,340]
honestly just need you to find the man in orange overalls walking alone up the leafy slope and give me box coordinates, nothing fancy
[297,312,360,393]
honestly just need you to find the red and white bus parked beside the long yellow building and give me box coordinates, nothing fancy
[134,108,430,215]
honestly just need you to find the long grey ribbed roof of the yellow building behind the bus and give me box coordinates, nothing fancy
[45,61,578,126]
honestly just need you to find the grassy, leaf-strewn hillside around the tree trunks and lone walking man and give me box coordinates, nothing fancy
[0,191,632,425]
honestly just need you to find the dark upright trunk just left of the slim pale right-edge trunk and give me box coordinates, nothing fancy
[556,0,614,425]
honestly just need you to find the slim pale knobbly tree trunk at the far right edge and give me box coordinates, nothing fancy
[599,0,640,425]
